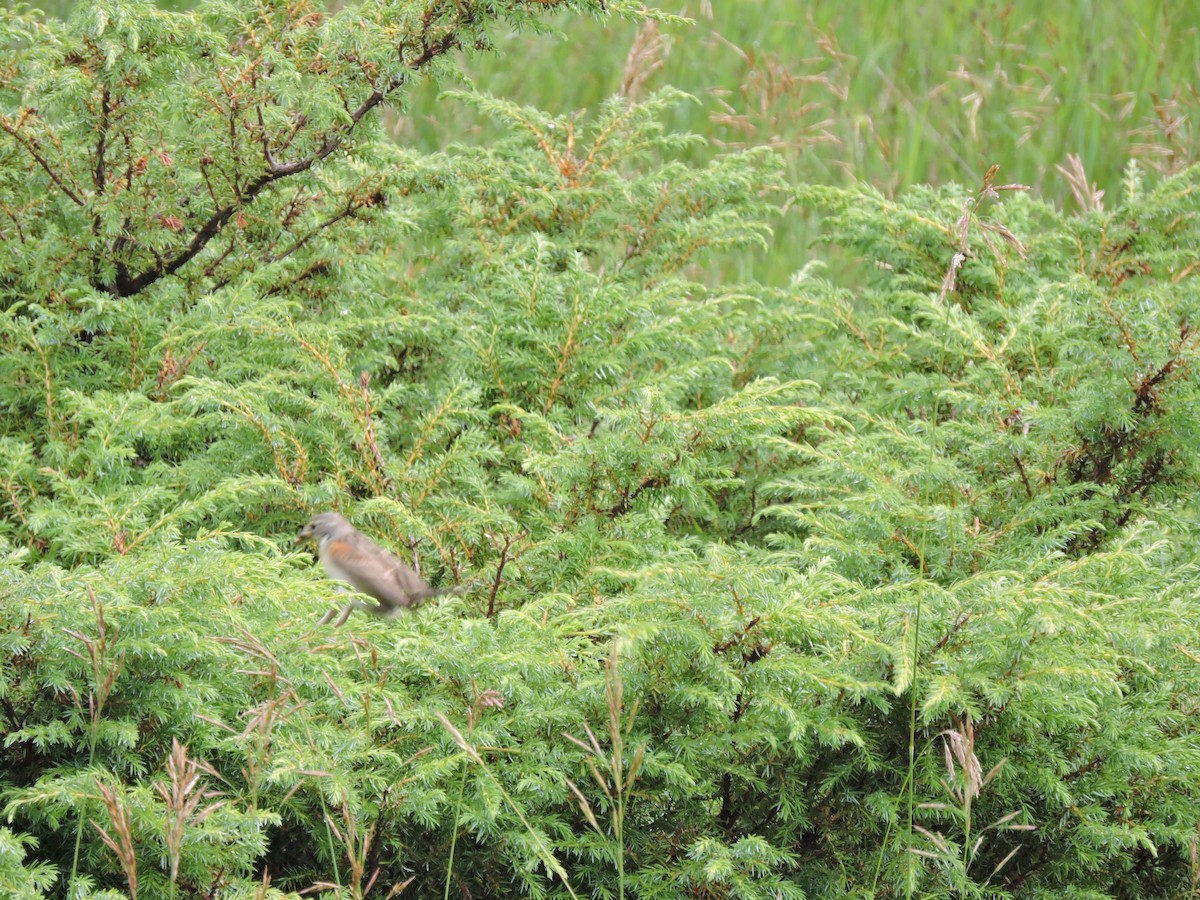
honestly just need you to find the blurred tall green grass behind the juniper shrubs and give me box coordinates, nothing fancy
[16,0,1200,283]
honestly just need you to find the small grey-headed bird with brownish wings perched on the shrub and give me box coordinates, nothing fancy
[296,512,456,625]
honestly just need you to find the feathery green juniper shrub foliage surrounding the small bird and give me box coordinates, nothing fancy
[0,0,1200,899]
